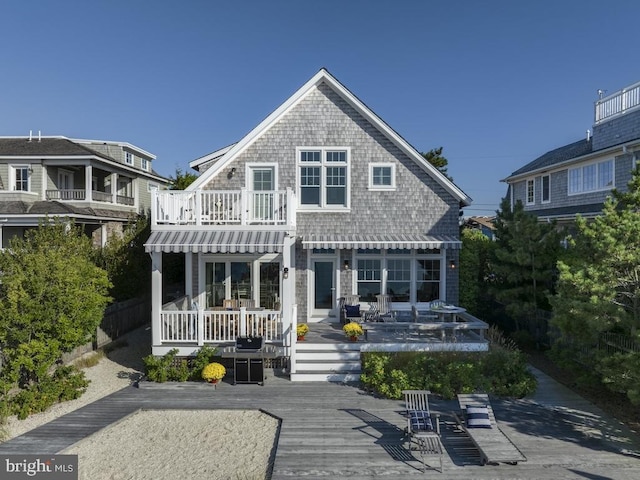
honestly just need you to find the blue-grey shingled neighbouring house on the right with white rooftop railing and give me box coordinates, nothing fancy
[503,79,640,224]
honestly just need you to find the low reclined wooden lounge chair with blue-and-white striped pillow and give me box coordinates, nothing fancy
[458,393,527,465]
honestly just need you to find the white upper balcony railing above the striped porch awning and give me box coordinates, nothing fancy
[151,189,296,225]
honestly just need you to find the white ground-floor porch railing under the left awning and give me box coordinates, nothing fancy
[160,308,283,346]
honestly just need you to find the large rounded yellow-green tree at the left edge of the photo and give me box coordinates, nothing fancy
[0,220,110,392]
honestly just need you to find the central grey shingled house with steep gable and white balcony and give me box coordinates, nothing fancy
[146,69,470,355]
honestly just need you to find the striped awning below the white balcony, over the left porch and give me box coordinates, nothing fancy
[144,230,285,253]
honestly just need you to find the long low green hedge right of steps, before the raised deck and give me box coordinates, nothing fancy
[361,346,537,399]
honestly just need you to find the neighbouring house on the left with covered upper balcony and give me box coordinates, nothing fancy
[0,135,169,248]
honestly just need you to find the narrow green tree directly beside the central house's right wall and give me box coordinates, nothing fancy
[459,228,493,318]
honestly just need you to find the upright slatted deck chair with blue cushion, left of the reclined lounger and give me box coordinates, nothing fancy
[402,390,443,472]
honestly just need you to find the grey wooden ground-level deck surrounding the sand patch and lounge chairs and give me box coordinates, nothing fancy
[0,371,640,480]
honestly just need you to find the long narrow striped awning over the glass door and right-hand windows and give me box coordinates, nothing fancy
[302,234,462,249]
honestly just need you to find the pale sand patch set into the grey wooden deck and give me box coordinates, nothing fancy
[61,410,278,480]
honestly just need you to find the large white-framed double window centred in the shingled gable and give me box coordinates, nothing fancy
[298,148,349,208]
